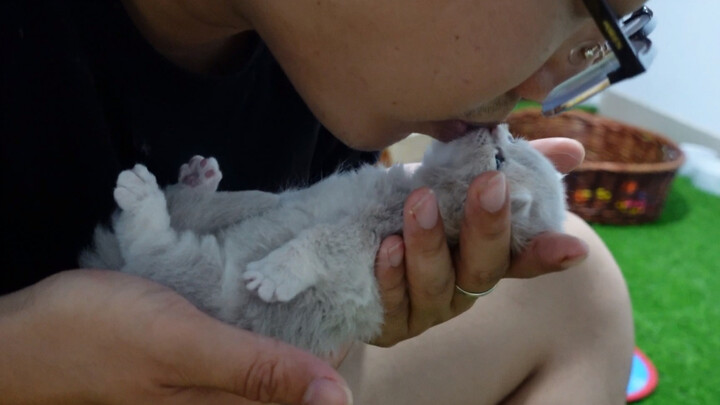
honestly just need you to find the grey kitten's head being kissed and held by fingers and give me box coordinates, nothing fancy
[423,125,565,252]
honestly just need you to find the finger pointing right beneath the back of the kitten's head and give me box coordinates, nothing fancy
[507,232,588,278]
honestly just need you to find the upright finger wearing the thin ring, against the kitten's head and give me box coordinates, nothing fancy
[453,172,510,313]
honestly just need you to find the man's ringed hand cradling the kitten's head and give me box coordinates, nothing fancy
[373,138,588,346]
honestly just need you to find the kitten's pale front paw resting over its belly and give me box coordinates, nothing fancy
[243,248,317,302]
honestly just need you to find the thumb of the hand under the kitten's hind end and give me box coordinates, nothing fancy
[165,315,352,405]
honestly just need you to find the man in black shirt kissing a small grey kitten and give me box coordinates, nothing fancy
[0,0,642,404]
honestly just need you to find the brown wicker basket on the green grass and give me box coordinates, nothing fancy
[508,109,684,225]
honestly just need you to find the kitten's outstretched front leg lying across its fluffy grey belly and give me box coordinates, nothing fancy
[243,224,379,302]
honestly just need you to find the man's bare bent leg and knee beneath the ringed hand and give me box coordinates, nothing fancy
[339,211,634,405]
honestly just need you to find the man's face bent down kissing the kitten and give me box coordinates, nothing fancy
[249,0,643,149]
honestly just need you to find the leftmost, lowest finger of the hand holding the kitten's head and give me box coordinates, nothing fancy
[372,235,410,347]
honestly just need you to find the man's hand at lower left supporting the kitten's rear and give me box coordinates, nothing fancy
[0,270,350,405]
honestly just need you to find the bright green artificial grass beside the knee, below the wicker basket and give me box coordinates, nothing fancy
[593,177,720,405]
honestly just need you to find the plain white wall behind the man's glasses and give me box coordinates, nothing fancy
[599,0,720,152]
